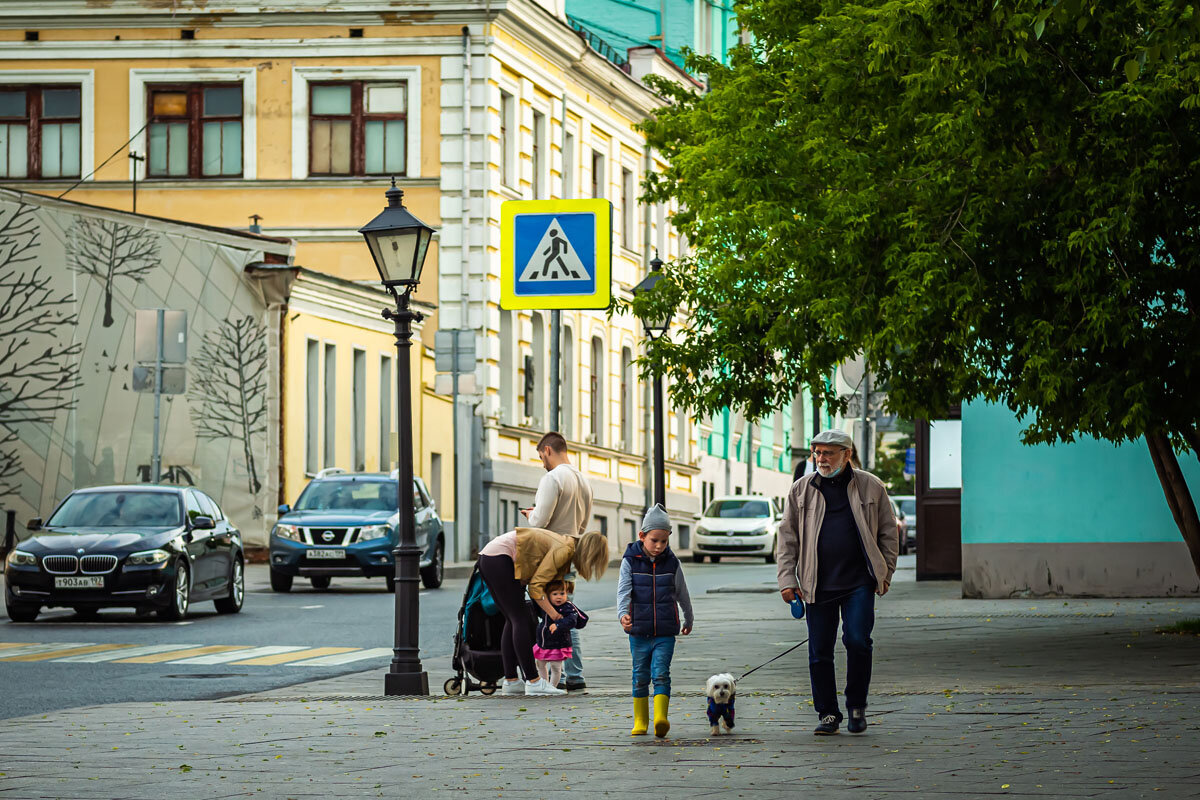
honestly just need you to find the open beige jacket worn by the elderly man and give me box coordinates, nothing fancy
[779,469,900,602]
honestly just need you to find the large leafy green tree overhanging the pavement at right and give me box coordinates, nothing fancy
[634,0,1200,571]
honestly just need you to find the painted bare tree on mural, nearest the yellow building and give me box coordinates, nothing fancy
[187,315,266,494]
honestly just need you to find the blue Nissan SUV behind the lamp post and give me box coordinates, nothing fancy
[270,468,445,591]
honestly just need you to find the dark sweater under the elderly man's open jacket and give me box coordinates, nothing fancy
[812,464,875,602]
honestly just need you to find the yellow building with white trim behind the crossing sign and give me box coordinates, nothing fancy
[0,0,698,559]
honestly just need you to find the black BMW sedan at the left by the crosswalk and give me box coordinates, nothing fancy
[5,485,245,622]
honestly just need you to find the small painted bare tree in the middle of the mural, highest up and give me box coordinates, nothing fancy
[67,216,160,327]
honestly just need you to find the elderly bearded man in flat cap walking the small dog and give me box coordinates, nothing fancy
[779,431,900,736]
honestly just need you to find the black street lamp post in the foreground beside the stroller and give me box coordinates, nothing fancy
[359,178,433,694]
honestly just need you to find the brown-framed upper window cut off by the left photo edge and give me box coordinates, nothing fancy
[0,85,80,180]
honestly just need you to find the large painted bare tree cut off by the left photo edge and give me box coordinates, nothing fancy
[0,203,82,495]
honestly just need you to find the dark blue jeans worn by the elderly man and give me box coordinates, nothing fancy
[804,585,875,720]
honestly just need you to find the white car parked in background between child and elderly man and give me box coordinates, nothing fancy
[691,494,780,564]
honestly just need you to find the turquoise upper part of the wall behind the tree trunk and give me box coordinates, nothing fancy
[962,403,1200,545]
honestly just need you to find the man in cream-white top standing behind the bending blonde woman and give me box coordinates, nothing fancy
[522,431,592,690]
